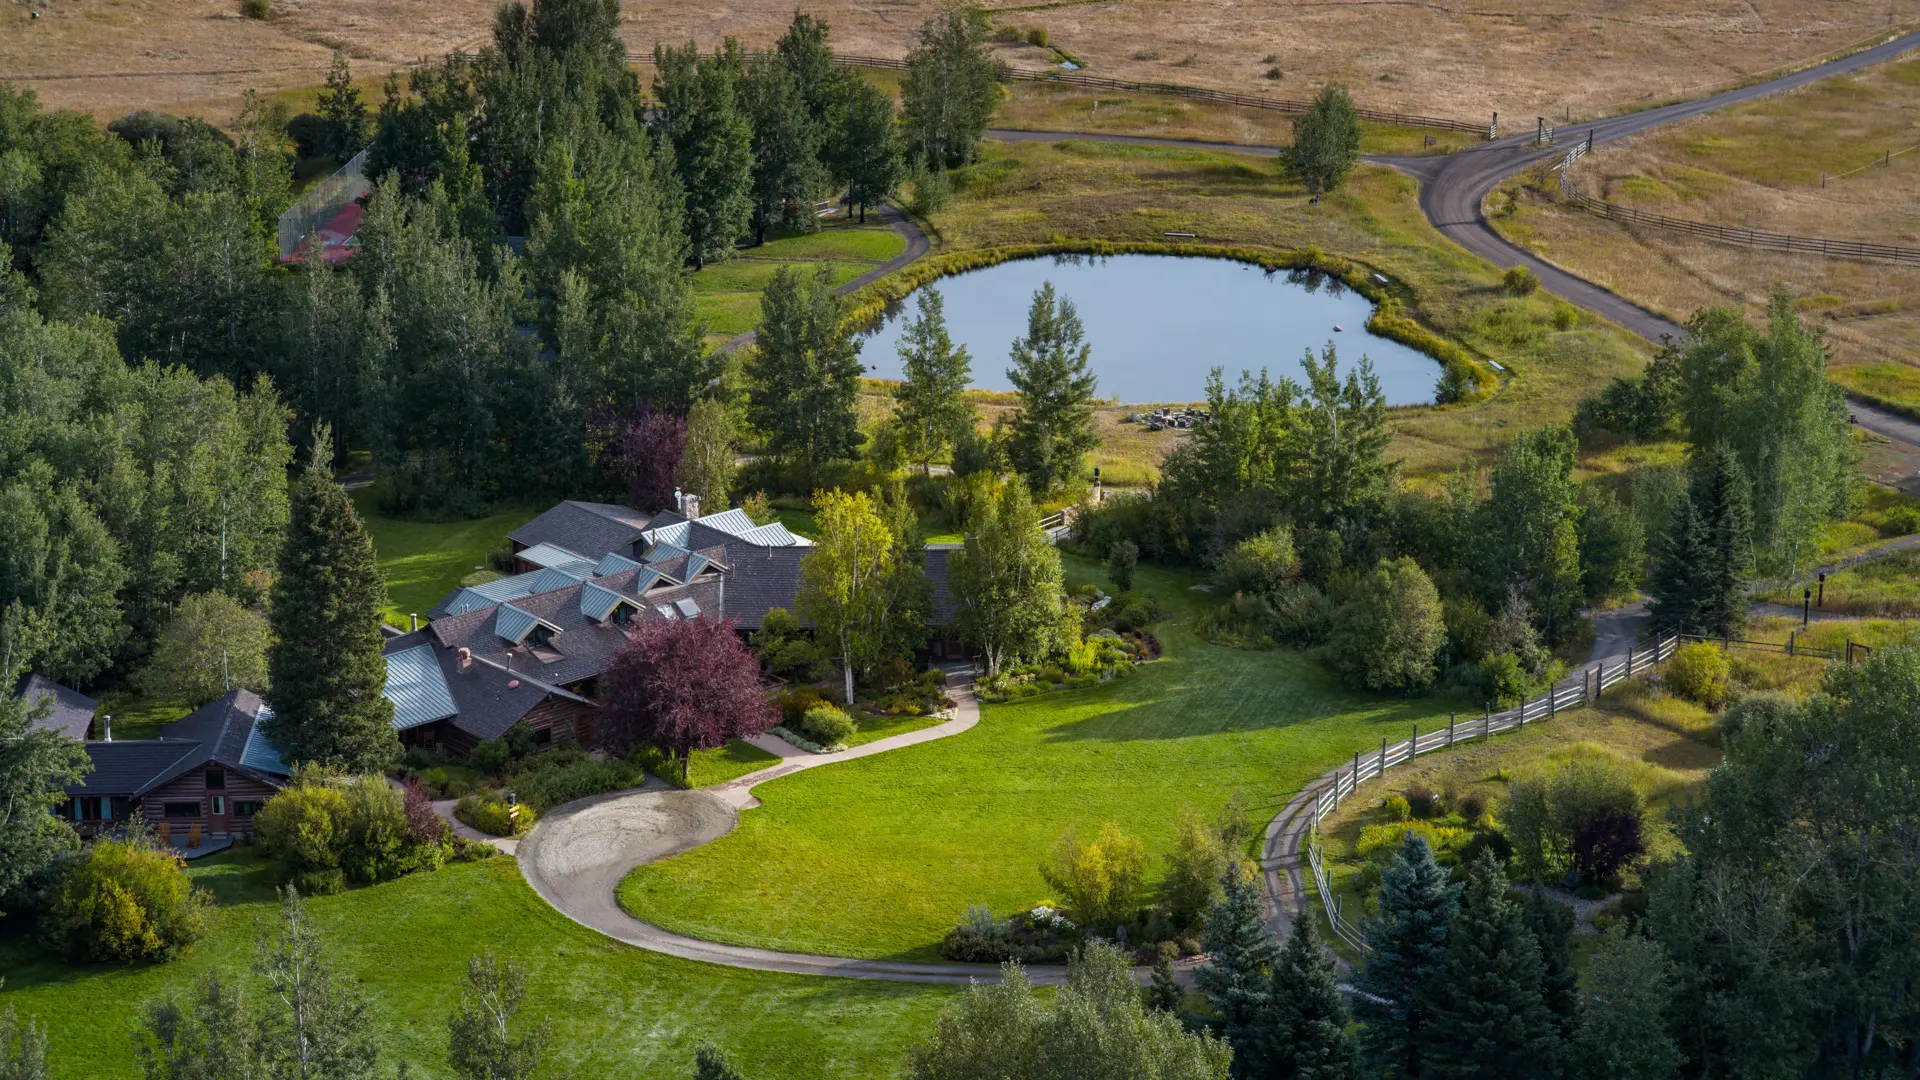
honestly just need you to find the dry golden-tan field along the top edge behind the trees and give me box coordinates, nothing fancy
[0,0,1920,121]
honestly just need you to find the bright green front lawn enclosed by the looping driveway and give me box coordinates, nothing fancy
[620,559,1446,959]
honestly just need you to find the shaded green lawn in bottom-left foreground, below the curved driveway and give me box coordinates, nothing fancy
[0,855,954,1080]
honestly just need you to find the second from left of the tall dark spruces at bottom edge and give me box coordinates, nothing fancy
[1260,913,1356,1080]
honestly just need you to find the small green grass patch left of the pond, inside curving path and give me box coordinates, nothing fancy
[691,215,906,336]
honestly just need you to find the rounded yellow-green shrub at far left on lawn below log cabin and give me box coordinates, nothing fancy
[44,819,213,961]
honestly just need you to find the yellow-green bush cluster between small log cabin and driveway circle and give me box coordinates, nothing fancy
[253,773,453,896]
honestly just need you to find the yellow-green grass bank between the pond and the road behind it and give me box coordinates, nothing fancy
[883,140,1645,475]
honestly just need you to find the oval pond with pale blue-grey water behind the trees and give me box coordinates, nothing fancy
[860,256,1440,405]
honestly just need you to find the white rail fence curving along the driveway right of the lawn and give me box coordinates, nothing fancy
[1308,634,1682,951]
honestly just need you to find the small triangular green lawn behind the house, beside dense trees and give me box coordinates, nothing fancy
[353,492,540,628]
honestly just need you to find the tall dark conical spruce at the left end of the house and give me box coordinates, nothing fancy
[267,425,399,771]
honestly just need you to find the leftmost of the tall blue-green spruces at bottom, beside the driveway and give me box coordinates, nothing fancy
[1194,867,1279,1076]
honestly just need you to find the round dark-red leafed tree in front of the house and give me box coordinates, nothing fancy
[605,619,780,761]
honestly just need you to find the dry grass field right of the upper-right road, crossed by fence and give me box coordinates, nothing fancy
[1488,60,1920,413]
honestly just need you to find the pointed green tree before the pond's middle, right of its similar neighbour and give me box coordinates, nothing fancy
[1006,281,1098,496]
